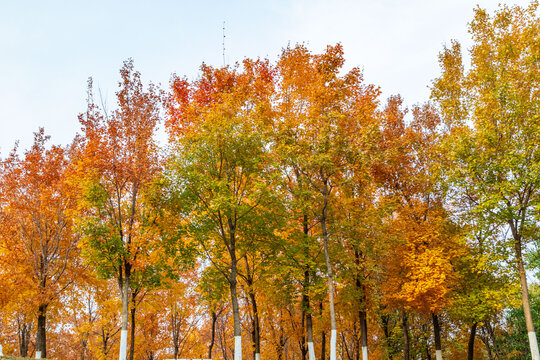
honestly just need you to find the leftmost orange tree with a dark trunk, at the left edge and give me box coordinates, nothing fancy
[0,129,80,358]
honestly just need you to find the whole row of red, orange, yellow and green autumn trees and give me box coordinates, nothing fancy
[0,2,540,360]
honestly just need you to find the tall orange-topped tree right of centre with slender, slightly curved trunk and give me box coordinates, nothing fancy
[277,45,379,360]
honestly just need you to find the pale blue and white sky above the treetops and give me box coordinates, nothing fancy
[0,0,529,153]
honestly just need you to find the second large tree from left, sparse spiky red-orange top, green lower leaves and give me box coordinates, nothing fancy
[74,60,163,360]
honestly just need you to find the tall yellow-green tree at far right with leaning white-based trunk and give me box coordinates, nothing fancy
[432,2,540,360]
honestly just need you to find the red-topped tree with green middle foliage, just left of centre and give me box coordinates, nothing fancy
[166,60,277,360]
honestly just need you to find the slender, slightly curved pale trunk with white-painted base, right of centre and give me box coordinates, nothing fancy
[320,187,337,360]
